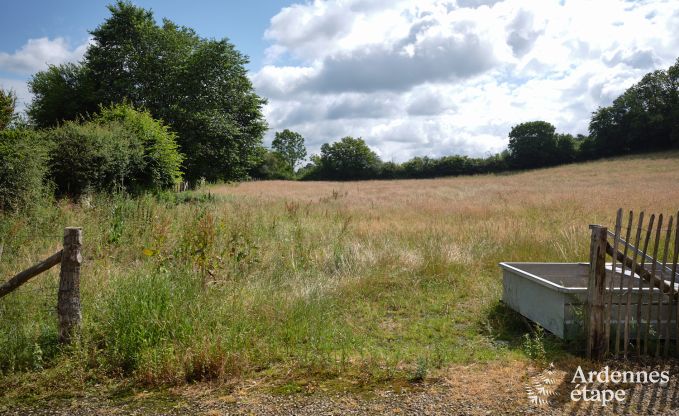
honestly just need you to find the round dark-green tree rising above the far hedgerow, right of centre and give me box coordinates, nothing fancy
[507,121,557,169]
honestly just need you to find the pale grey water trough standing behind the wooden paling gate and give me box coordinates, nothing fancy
[500,263,677,339]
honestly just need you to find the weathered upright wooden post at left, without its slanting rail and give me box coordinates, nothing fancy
[57,227,82,344]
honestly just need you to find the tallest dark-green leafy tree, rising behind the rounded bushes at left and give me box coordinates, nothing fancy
[29,1,267,180]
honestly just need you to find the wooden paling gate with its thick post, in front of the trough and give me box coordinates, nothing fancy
[585,209,679,359]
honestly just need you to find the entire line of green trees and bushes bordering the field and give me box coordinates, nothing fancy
[0,0,679,210]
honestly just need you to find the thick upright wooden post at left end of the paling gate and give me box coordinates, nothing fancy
[585,225,609,360]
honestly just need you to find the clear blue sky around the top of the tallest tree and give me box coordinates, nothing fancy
[0,0,292,70]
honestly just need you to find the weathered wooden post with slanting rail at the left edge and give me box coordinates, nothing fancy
[0,227,82,344]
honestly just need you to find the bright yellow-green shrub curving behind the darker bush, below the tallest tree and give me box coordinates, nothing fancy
[96,104,184,190]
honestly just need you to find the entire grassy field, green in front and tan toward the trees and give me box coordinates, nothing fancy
[0,153,679,402]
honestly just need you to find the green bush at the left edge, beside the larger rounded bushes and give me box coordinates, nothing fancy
[0,129,49,211]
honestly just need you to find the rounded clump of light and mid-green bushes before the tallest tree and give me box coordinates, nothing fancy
[50,105,183,197]
